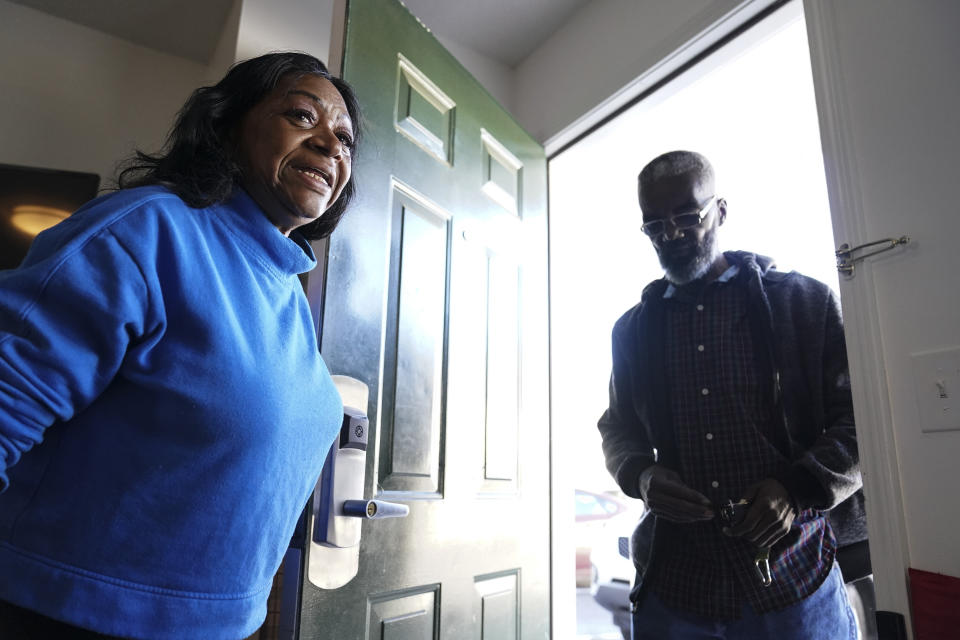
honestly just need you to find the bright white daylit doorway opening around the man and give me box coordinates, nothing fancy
[549,2,872,640]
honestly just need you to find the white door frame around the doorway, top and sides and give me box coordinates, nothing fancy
[544,0,912,637]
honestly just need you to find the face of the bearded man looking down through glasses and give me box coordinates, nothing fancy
[640,173,726,285]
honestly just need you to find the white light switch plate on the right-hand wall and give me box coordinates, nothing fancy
[910,347,960,433]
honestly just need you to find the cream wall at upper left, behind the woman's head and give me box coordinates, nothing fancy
[0,0,204,185]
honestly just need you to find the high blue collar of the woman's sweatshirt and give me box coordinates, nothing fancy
[217,187,317,277]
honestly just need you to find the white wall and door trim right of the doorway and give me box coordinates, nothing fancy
[804,0,960,624]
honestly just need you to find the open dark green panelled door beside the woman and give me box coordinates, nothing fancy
[299,0,550,640]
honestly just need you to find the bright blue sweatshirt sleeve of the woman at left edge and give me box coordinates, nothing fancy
[0,226,149,492]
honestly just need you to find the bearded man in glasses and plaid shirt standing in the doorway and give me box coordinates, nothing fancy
[598,151,866,640]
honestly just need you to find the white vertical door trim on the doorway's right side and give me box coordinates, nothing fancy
[803,0,911,633]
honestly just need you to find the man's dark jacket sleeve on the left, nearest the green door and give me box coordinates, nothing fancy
[597,322,656,498]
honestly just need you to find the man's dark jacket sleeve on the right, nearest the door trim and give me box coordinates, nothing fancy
[778,292,863,510]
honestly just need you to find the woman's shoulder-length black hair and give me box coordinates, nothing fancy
[117,52,360,240]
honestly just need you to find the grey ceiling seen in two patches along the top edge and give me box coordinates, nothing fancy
[12,0,588,67]
